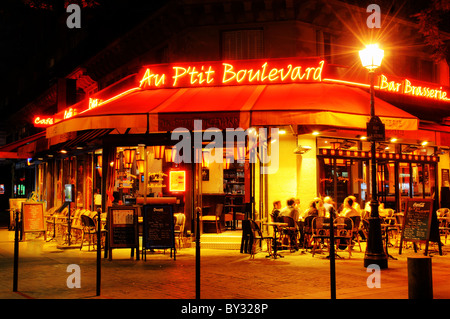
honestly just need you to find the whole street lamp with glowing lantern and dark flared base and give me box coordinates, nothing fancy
[359,44,388,269]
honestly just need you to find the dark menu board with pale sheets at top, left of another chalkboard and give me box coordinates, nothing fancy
[108,206,139,248]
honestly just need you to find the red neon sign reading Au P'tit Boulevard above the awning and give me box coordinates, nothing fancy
[139,59,324,89]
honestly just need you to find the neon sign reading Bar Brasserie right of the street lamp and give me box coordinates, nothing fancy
[379,74,450,101]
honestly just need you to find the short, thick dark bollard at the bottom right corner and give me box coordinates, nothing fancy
[408,256,433,299]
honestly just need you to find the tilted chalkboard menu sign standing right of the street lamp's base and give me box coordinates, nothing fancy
[399,199,433,254]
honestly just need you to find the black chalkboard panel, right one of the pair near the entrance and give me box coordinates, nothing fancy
[143,205,175,249]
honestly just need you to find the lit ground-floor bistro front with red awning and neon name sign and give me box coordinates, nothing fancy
[19,58,449,238]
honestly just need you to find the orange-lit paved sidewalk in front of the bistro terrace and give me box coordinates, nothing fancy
[0,229,450,300]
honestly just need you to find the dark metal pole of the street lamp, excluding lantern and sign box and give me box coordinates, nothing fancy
[364,71,388,269]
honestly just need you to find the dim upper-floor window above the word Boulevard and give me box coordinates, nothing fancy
[222,29,264,60]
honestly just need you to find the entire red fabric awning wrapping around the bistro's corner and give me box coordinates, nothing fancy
[47,83,419,137]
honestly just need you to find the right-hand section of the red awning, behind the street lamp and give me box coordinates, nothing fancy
[251,84,419,130]
